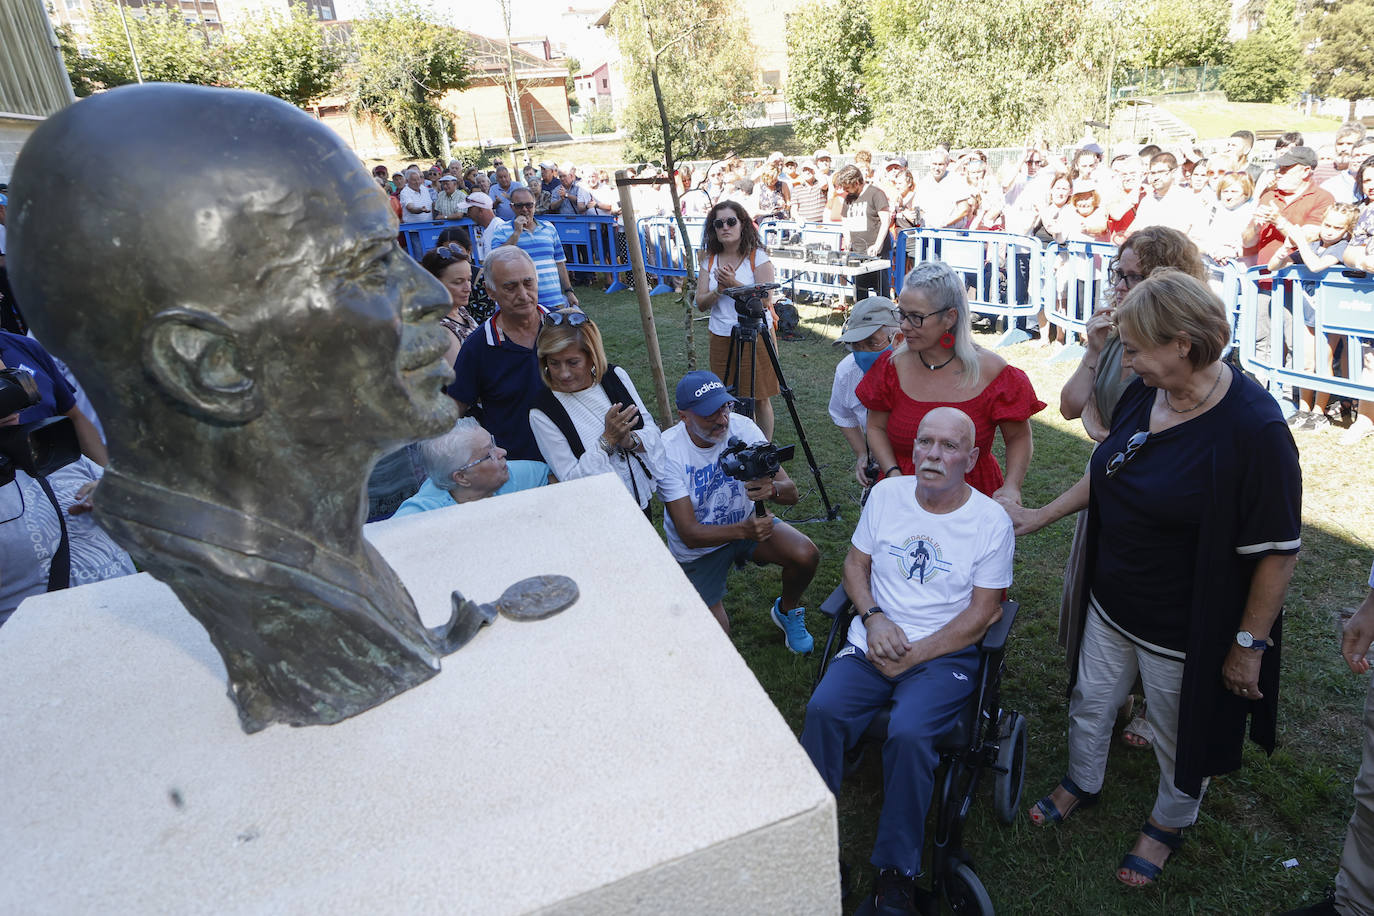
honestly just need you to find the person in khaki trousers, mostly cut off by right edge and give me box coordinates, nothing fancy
[1282,569,1374,916]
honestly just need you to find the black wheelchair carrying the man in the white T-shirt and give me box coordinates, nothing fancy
[812,585,1026,916]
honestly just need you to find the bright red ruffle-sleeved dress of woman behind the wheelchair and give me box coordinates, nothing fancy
[855,352,1044,496]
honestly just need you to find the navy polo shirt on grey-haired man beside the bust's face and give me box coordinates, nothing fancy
[448,308,545,461]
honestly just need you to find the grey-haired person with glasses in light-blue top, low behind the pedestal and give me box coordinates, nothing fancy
[392,416,548,518]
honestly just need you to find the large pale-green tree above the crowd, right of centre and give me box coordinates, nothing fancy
[864,0,1113,150]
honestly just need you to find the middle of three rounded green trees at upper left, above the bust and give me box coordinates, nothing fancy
[228,3,344,106]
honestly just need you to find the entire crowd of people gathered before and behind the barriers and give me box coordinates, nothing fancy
[0,118,1374,913]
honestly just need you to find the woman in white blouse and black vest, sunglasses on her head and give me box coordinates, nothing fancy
[529,309,668,520]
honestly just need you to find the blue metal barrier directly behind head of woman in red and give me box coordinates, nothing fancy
[893,229,1046,346]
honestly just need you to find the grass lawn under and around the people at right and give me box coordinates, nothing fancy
[566,281,1374,916]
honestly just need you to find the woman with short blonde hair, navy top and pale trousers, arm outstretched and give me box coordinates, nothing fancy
[1007,271,1301,887]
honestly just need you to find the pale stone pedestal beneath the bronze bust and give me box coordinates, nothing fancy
[0,477,840,915]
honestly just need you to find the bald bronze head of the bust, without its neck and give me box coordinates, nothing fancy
[10,84,453,469]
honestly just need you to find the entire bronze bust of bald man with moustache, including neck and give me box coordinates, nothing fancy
[8,84,574,732]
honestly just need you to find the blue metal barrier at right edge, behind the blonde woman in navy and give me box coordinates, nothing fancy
[1238,266,1374,404]
